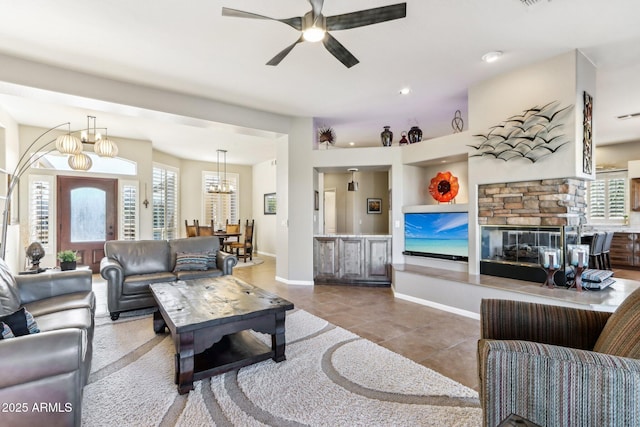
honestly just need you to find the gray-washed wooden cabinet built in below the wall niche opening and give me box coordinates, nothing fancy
[313,235,391,286]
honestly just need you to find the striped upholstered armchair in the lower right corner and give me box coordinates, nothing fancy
[478,289,640,427]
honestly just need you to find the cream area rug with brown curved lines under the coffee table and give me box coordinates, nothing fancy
[82,310,481,427]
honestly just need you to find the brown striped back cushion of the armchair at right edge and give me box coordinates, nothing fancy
[593,289,640,359]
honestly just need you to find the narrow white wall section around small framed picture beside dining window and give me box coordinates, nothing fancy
[253,159,277,256]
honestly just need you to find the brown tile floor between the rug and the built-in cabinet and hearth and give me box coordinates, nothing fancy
[94,256,640,390]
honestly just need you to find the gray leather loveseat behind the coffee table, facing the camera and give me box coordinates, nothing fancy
[100,236,238,320]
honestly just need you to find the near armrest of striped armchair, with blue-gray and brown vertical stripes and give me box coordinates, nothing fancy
[478,340,640,426]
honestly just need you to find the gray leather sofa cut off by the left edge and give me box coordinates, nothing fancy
[0,259,95,426]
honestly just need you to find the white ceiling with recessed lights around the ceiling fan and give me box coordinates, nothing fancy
[0,0,640,164]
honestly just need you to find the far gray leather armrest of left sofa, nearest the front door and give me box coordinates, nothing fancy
[16,270,91,305]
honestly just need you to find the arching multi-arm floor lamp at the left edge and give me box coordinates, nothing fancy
[0,122,82,259]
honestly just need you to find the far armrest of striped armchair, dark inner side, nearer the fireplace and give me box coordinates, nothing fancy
[480,299,611,350]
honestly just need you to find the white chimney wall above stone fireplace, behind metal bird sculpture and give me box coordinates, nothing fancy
[469,51,597,184]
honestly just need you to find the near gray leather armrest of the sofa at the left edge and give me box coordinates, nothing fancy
[0,328,87,392]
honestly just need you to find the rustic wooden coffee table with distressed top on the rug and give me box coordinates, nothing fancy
[149,276,293,394]
